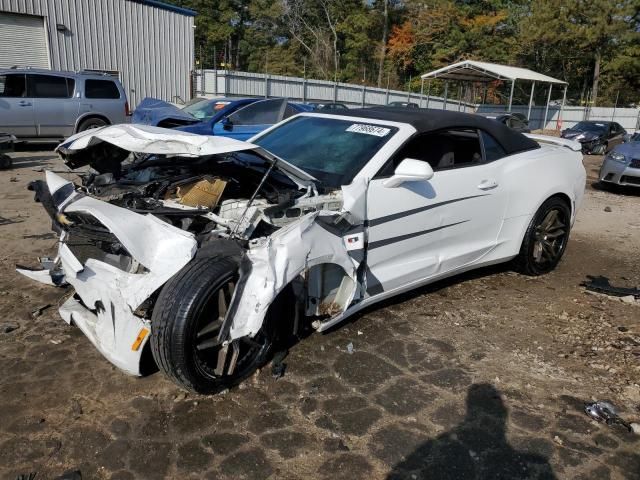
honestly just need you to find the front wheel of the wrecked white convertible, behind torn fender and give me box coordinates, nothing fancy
[151,257,273,394]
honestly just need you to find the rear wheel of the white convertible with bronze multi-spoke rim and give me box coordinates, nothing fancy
[514,197,571,276]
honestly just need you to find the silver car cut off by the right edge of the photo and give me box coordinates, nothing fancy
[598,133,640,187]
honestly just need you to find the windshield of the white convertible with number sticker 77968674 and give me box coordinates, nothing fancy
[253,116,398,188]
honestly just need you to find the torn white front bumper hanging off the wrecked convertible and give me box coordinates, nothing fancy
[17,172,197,375]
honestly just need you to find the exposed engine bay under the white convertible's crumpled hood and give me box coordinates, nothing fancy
[69,143,342,240]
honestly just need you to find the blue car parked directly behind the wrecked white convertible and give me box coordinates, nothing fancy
[131,98,312,140]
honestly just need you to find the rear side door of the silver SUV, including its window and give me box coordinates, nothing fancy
[27,74,79,138]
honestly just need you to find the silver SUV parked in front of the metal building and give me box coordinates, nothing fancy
[0,68,129,141]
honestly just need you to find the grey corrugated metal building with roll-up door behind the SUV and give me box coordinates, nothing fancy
[0,0,196,107]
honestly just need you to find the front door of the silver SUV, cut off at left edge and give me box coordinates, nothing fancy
[0,73,36,137]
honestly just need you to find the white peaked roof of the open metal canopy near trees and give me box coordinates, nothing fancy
[421,60,567,85]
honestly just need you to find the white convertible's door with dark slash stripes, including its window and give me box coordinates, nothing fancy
[367,129,506,294]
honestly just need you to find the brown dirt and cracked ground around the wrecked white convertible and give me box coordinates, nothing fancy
[0,151,640,480]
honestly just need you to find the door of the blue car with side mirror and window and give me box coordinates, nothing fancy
[213,98,288,140]
